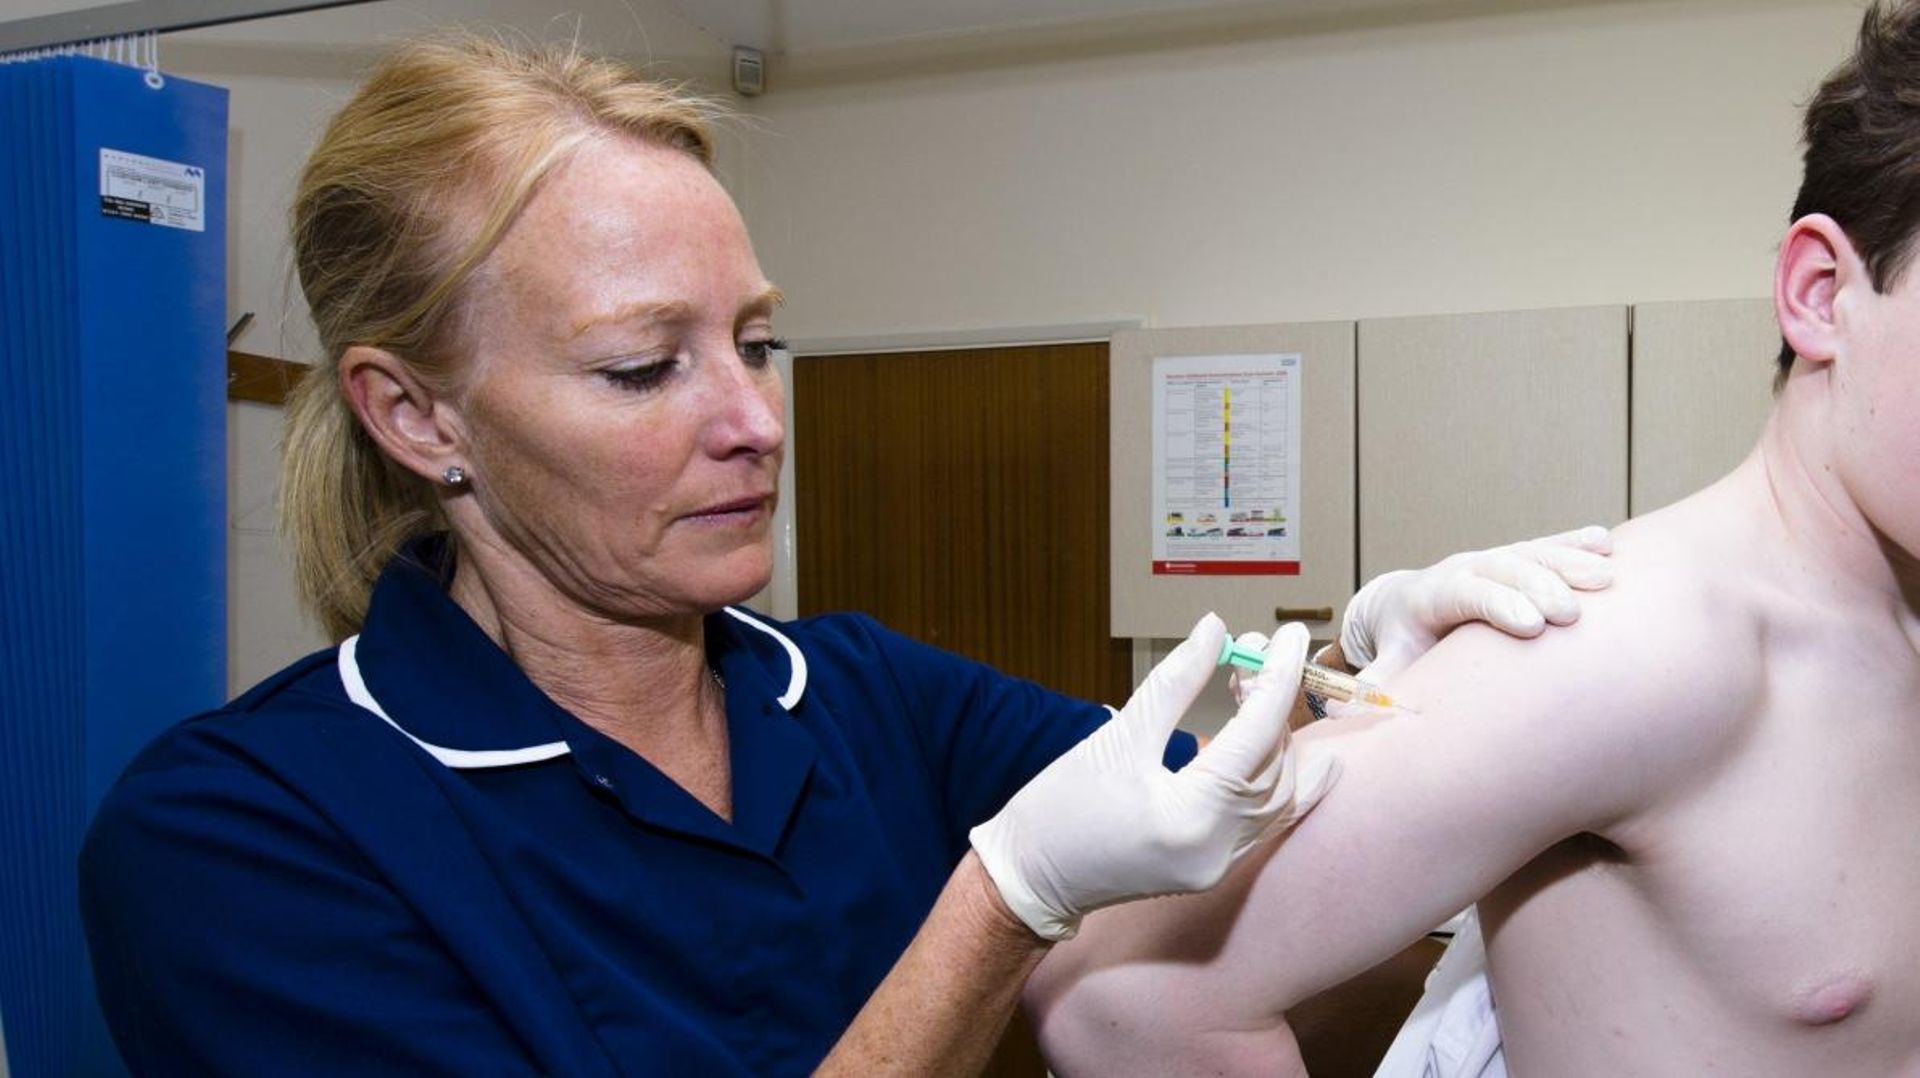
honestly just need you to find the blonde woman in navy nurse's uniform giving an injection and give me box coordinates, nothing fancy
[81,38,1594,1074]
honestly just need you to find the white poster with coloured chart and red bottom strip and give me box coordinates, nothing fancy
[1154,354,1300,576]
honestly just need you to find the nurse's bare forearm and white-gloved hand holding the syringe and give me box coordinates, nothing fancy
[818,615,1336,1074]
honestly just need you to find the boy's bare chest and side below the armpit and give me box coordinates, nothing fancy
[1484,669,1920,1072]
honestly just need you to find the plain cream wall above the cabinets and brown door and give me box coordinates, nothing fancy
[743,0,1859,343]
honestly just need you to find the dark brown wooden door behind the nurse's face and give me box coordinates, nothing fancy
[793,342,1131,703]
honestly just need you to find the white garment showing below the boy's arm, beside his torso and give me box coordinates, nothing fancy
[1373,909,1507,1078]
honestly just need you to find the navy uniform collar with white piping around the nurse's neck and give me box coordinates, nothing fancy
[336,536,806,769]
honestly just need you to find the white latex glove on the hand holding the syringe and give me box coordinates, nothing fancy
[970,615,1338,940]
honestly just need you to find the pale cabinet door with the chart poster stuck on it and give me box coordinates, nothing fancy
[1110,323,1354,638]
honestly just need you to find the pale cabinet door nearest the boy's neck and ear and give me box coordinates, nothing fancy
[1632,300,1780,517]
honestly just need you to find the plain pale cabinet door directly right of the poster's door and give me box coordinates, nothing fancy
[1359,307,1626,578]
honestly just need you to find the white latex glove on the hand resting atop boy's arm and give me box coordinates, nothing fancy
[1340,525,1613,682]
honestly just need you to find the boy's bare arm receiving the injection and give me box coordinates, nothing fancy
[1029,573,1758,1068]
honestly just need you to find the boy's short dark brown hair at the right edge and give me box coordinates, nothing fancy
[1774,0,1920,392]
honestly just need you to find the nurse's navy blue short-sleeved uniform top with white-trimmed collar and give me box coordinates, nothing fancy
[81,548,1194,1074]
